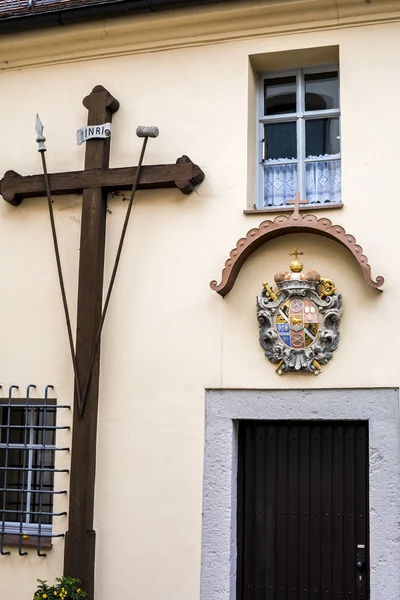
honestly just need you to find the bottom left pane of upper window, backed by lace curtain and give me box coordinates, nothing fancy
[264,163,298,206]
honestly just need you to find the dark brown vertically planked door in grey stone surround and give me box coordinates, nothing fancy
[237,421,369,600]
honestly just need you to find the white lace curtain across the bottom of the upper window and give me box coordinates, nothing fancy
[264,157,341,207]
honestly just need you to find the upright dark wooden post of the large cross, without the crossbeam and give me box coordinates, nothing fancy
[64,86,119,600]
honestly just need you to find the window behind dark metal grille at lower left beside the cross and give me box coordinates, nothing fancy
[0,384,71,557]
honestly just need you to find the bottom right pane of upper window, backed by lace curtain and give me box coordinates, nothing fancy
[306,160,341,204]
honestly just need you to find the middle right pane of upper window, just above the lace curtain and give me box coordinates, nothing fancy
[306,117,340,158]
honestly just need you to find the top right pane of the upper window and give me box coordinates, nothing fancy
[304,71,339,110]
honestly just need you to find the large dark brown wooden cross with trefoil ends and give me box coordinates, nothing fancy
[0,86,204,600]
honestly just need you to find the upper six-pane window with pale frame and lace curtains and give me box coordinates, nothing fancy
[257,65,342,209]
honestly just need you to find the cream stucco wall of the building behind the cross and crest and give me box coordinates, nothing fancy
[0,2,400,600]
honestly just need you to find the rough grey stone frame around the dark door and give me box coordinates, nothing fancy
[201,388,400,600]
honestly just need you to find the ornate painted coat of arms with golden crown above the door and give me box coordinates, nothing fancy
[257,248,343,375]
